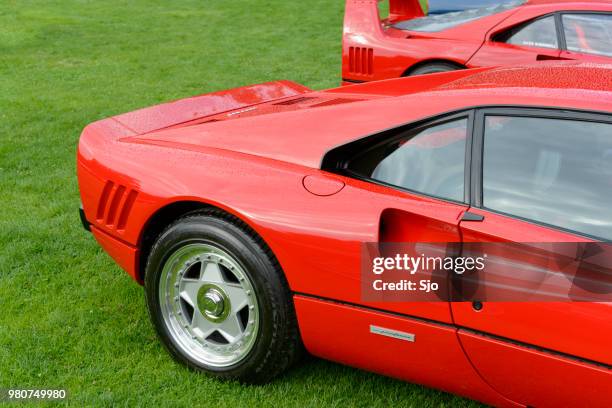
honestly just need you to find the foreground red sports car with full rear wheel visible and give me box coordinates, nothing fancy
[77,62,612,407]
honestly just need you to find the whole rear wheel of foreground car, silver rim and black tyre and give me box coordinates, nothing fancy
[145,210,302,383]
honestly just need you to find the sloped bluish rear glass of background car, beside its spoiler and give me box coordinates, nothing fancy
[393,0,525,33]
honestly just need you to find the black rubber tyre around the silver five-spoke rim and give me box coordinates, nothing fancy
[145,216,284,378]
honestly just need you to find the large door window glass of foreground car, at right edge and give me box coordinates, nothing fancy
[482,116,612,239]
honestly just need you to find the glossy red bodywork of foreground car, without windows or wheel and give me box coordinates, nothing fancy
[77,63,612,406]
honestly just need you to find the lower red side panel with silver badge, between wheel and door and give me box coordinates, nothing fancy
[295,295,520,406]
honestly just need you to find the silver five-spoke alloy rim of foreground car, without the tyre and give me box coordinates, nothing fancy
[159,244,259,367]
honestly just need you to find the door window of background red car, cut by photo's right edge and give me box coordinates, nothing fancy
[562,14,612,57]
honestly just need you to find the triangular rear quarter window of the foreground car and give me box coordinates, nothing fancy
[347,118,468,201]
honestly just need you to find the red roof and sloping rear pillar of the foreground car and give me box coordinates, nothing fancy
[137,63,612,168]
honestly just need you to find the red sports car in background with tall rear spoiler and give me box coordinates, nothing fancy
[342,0,612,83]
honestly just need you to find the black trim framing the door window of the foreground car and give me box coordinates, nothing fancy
[470,106,612,242]
